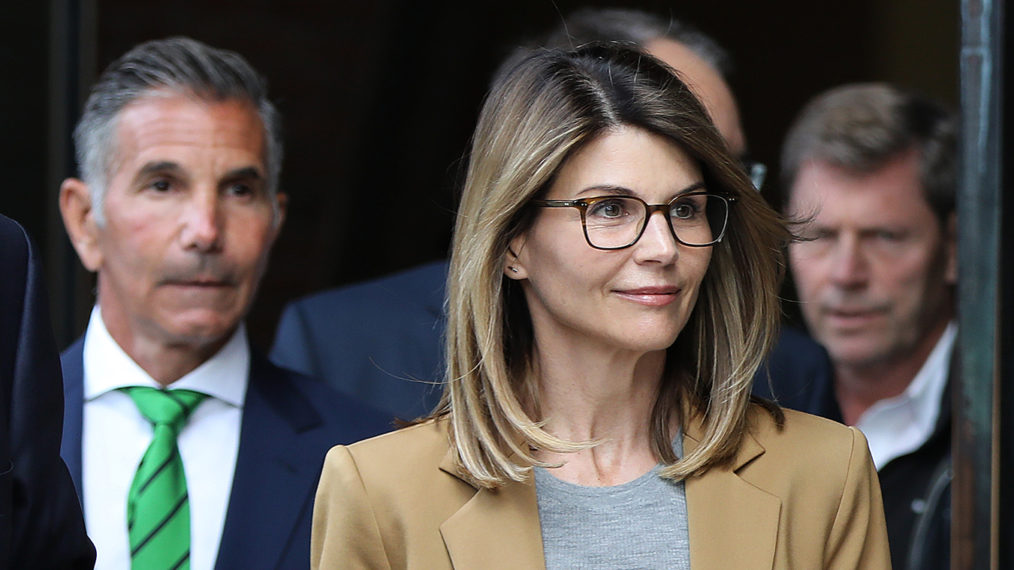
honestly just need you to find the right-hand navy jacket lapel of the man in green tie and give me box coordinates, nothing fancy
[216,353,322,568]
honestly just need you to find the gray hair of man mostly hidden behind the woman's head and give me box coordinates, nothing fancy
[542,8,732,79]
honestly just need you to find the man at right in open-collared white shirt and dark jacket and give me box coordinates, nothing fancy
[774,84,956,569]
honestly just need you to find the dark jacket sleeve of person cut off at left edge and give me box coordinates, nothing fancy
[0,216,95,568]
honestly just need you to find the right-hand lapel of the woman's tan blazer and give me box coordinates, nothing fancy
[683,419,782,570]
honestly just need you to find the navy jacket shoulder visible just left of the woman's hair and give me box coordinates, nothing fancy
[271,261,447,420]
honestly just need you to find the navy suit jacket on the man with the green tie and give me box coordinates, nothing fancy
[62,339,391,568]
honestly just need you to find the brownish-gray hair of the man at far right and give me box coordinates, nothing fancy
[781,83,957,223]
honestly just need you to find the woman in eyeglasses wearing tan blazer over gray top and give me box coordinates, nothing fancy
[311,45,890,570]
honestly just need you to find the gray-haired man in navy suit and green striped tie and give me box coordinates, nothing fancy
[60,38,387,569]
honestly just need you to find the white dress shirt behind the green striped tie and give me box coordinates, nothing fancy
[81,306,249,570]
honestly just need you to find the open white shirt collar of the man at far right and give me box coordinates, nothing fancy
[856,323,957,471]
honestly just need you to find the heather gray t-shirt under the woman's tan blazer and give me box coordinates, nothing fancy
[534,437,691,570]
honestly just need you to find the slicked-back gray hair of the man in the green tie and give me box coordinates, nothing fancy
[74,38,282,224]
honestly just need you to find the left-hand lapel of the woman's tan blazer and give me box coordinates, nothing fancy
[440,451,546,570]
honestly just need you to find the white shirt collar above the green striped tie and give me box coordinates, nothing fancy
[82,305,250,408]
